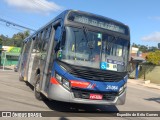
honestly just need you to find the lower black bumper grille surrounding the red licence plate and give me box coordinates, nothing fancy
[72,89,118,101]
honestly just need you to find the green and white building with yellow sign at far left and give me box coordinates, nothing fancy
[0,46,21,66]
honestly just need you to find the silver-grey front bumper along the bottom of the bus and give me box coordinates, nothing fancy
[48,84,126,105]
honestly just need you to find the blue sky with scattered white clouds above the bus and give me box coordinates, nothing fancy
[0,0,160,47]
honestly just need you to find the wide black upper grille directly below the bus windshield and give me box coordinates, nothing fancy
[58,61,127,82]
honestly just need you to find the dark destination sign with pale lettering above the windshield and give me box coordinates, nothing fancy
[68,12,127,34]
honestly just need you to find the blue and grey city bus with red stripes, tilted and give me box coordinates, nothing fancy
[19,10,130,105]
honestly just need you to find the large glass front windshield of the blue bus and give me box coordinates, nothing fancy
[61,27,129,72]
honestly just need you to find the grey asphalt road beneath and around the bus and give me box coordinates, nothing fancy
[0,71,160,120]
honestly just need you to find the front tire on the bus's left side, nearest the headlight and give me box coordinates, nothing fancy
[34,75,43,100]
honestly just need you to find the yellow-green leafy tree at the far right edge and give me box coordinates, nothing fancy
[147,50,160,65]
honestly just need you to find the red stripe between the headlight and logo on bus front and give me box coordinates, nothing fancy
[70,80,90,88]
